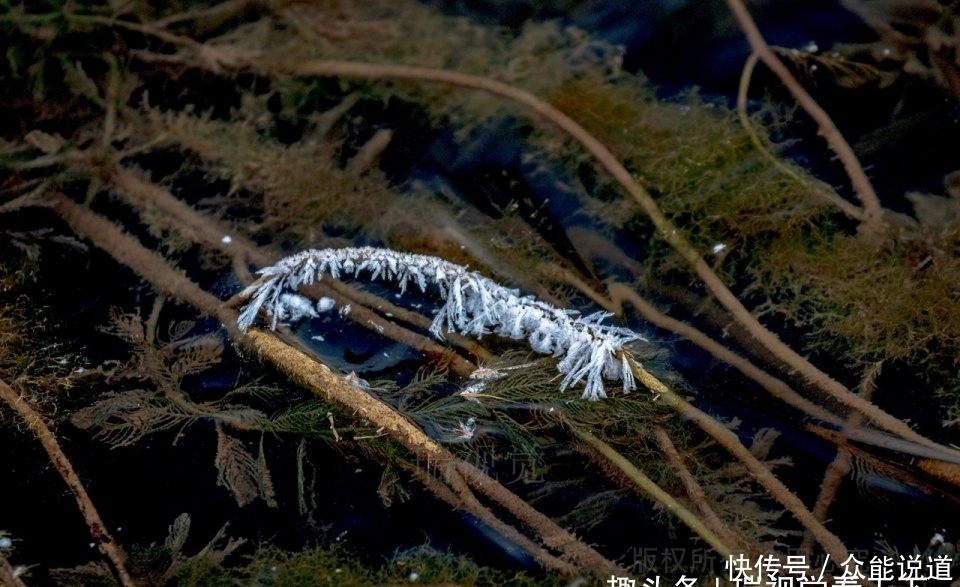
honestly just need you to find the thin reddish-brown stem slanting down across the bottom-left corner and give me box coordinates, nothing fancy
[0,380,134,587]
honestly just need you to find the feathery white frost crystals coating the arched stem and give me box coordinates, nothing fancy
[239,247,643,400]
